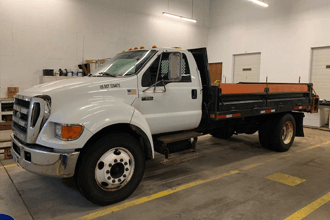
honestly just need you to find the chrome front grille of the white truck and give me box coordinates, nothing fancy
[12,95,45,143]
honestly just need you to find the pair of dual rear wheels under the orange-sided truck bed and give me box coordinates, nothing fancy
[259,114,296,152]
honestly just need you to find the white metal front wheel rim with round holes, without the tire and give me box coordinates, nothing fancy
[95,147,135,191]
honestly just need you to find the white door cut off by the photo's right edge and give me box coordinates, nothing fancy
[311,47,330,100]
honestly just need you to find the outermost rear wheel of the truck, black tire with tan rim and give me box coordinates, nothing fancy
[270,114,296,152]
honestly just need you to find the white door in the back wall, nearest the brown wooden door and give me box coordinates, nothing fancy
[234,53,261,83]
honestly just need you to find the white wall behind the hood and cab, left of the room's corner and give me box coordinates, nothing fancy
[0,0,209,97]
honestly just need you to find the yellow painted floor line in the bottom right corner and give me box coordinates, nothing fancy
[285,192,330,220]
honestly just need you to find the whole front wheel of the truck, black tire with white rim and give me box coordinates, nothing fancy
[75,133,145,205]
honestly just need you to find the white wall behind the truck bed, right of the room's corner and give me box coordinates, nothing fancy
[208,0,330,82]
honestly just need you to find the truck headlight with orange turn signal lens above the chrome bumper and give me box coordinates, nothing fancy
[55,124,84,141]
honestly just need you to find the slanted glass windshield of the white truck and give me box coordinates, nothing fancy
[91,50,156,77]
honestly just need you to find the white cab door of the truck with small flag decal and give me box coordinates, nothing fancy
[133,53,202,134]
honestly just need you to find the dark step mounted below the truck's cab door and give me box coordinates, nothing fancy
[155,131,202,159]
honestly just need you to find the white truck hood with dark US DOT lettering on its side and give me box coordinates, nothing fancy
[19,76,137,111]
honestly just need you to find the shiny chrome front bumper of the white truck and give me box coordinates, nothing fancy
[11,134,80,177]
